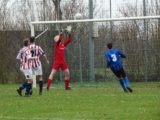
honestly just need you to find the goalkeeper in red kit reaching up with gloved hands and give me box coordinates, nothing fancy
[47,26,71,90]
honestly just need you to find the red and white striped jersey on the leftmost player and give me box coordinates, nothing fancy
[16,47,32,70]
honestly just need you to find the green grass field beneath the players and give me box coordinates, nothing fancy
[0,82,160,120]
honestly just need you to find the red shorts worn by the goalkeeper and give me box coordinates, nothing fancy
[52,62,68,71]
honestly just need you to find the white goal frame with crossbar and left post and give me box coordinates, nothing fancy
[30,15,160,87]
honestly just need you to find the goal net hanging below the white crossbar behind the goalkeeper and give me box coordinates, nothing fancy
[31,16,160,86]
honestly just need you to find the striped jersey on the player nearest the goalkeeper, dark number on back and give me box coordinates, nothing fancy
[29,43,44,68]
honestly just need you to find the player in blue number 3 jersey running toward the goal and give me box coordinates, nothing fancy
[105,43,132,92]
